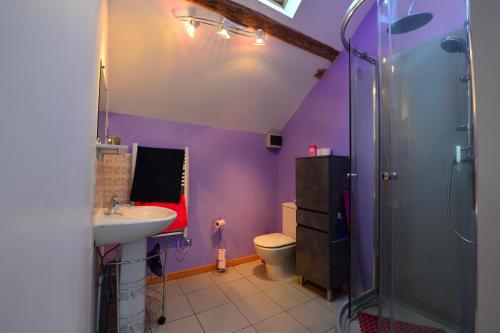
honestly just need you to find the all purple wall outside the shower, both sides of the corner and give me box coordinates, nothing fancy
[104,8,377,272]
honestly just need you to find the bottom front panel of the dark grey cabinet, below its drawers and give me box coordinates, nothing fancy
[296,226,330,289]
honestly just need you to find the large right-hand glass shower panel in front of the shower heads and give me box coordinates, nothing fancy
[379,0,476,333]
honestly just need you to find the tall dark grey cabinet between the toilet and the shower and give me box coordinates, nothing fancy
[295,156,349,300]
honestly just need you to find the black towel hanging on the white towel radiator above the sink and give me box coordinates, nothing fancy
[130,147,184,203]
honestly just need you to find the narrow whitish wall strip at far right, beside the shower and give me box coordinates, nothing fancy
[471,0,500,333]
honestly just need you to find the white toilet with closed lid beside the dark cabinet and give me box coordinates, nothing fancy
[253,202,297,280]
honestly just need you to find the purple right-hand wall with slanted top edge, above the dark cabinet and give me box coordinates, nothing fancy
[277,6,377,222]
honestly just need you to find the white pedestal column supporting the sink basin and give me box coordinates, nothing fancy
[118,239,148,333]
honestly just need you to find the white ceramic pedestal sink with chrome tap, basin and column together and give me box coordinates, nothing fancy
[94,206,177,333]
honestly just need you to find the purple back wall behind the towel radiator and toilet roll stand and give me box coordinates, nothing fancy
[109,113,277,272]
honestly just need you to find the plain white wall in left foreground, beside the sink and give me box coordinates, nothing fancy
[0,0,100,333]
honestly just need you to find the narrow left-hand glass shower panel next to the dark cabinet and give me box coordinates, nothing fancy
[349,42,378,317]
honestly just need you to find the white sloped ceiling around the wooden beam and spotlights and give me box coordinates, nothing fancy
[107,0,372,133]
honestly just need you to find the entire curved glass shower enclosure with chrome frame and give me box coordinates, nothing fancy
[338,0,477,333]
